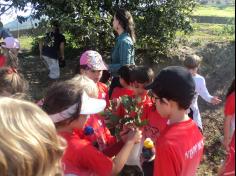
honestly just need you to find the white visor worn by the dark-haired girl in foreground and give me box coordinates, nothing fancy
[49,92,106,123]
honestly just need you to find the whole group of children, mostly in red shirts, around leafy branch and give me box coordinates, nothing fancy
[0,47,235,176]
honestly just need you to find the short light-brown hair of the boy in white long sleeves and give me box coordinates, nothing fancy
[184,54,202,69]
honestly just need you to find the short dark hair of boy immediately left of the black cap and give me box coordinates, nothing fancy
[130,66,154,84]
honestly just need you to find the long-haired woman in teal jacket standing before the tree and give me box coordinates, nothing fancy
[109,9,135,75]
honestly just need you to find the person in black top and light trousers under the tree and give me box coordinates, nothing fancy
[39,21,66,79]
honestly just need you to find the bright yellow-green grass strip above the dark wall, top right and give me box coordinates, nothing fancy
[193,5,235,17]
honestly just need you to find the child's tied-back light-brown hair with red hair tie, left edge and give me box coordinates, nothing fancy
[0,67,29,96]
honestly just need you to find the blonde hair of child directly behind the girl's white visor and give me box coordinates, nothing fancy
[69,74,98,98]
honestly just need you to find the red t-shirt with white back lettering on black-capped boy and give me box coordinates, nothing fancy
[154,119,204,176]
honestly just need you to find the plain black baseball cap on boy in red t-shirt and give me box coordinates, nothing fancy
[146,66,195,109]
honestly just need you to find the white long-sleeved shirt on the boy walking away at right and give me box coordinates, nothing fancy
[190,74,213,129]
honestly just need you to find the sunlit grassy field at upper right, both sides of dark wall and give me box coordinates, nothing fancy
[177,5,235,46]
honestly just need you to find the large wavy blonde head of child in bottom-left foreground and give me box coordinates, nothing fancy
[0,97,65,176]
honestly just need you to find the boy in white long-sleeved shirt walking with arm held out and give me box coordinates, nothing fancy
[184,55,221,131]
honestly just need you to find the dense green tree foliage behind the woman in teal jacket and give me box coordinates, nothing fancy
[1,0,196,61]
